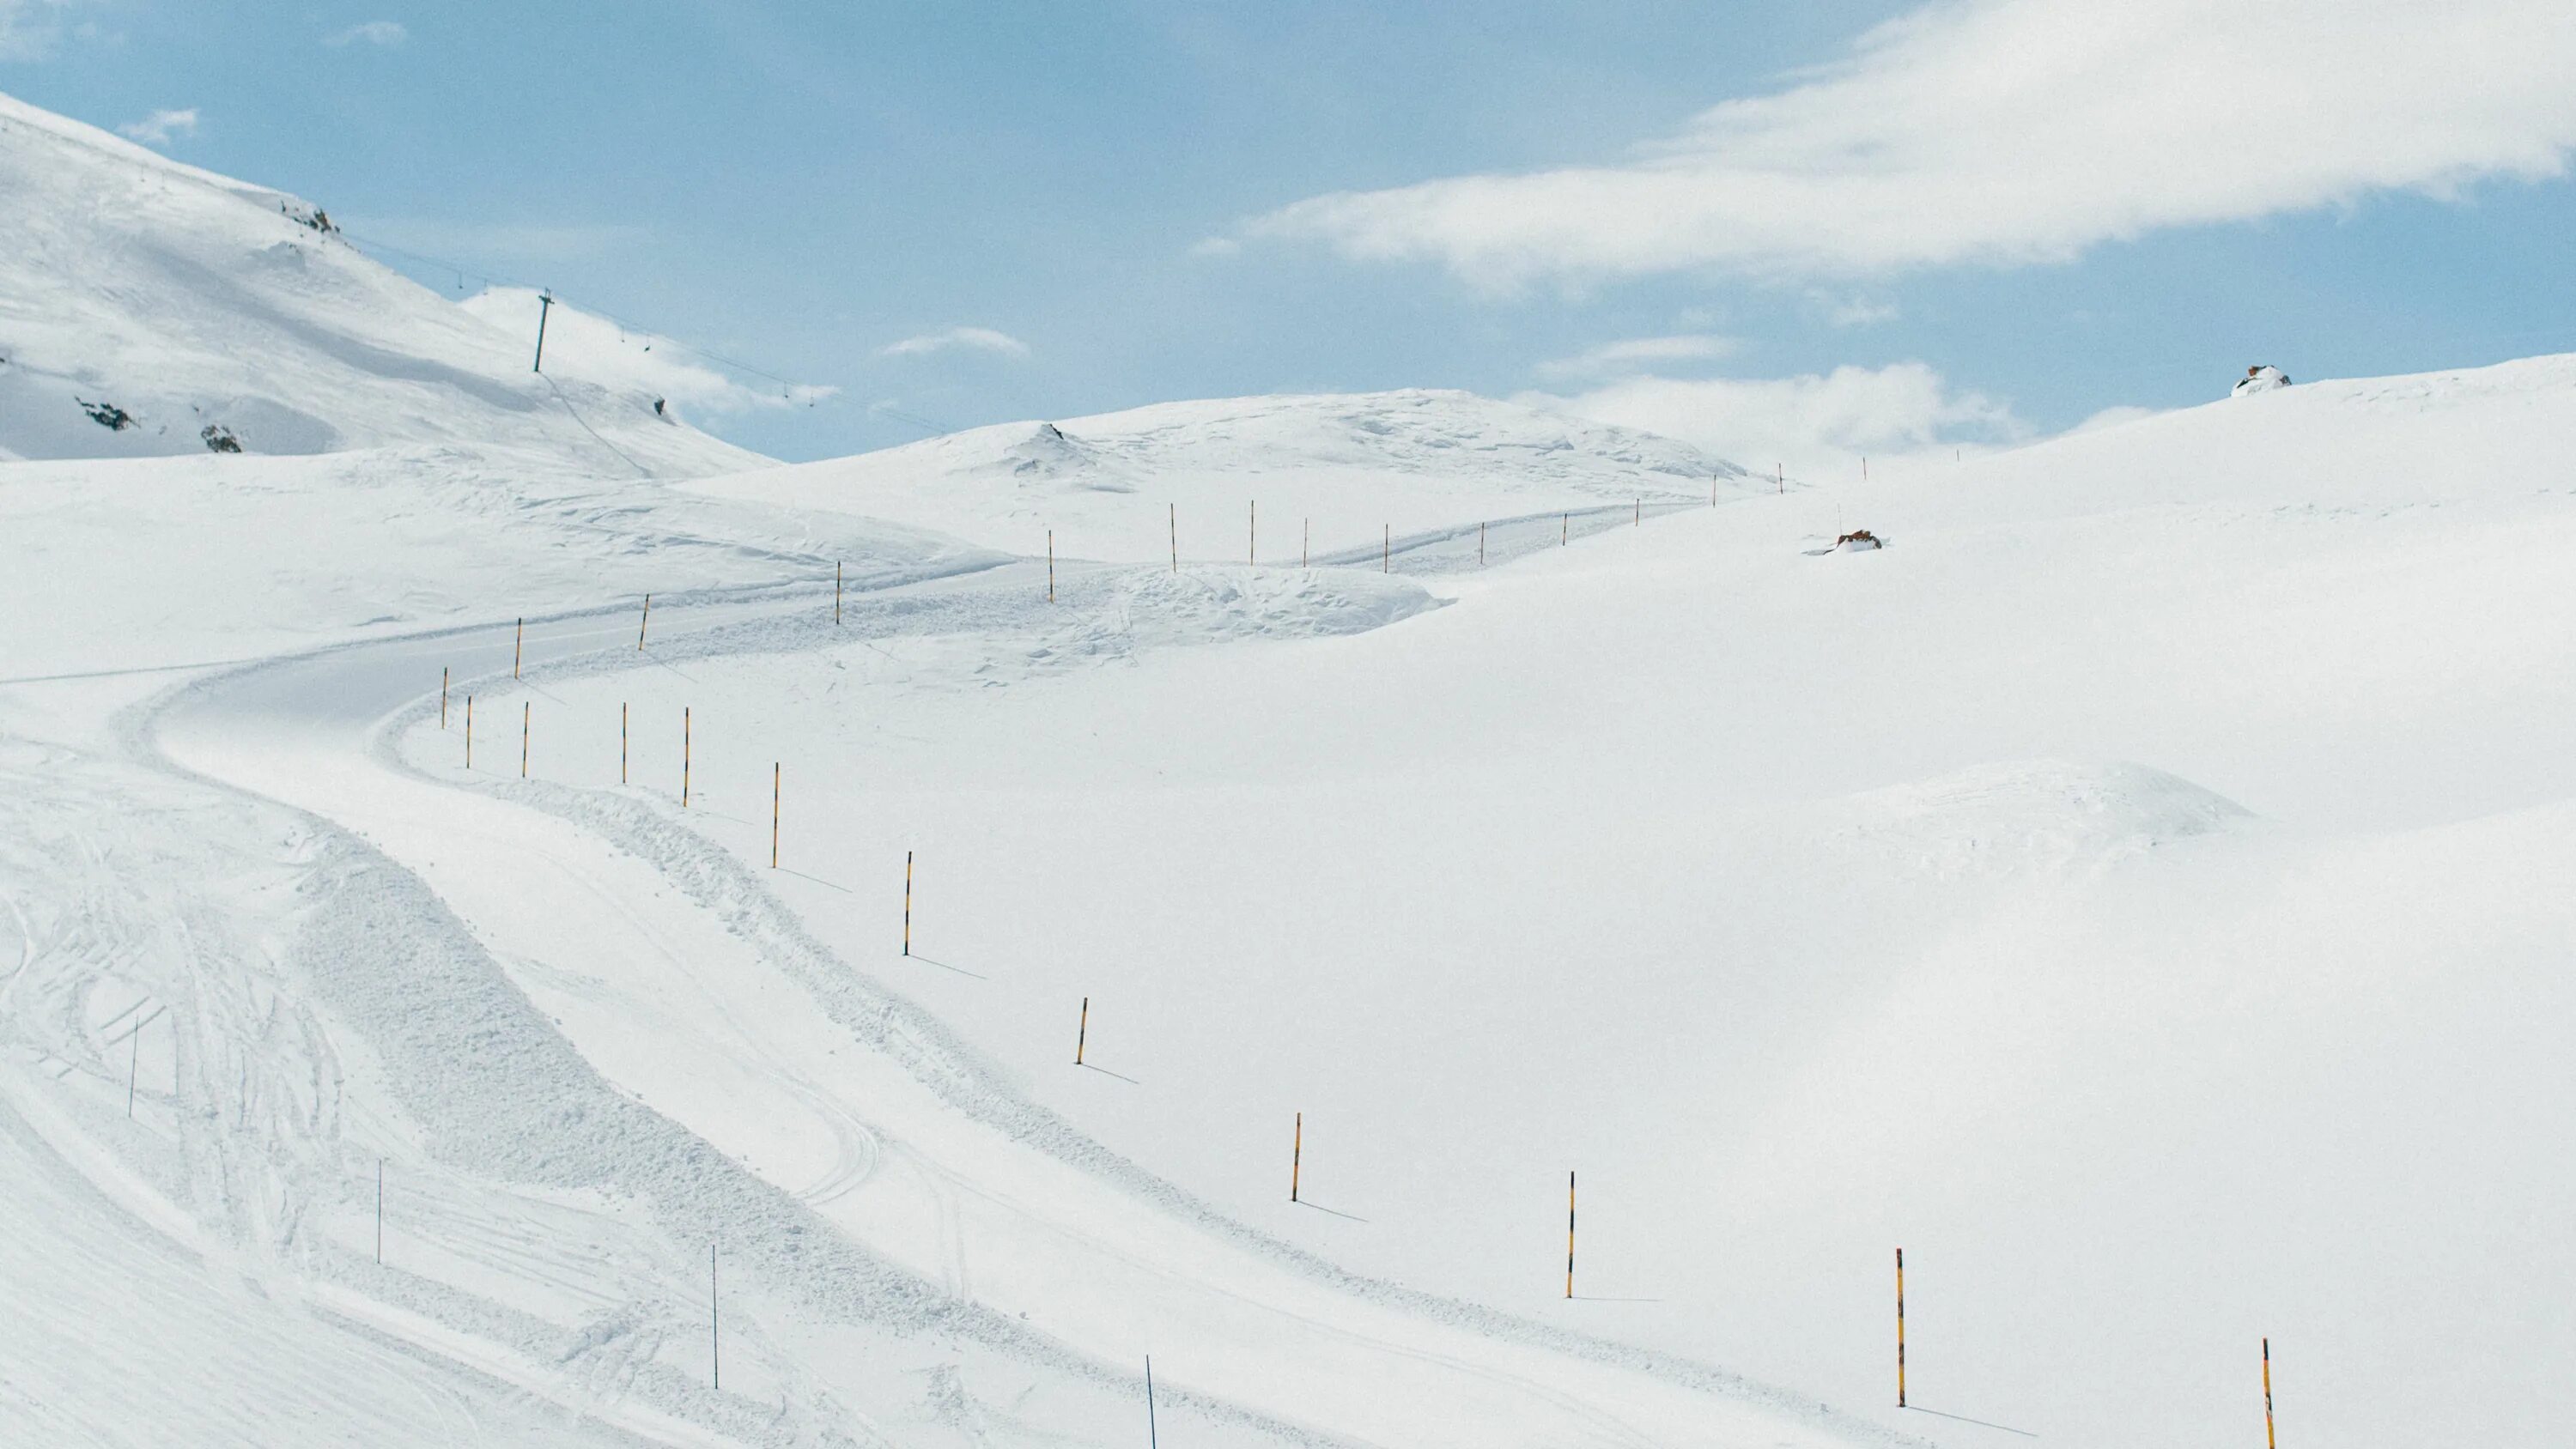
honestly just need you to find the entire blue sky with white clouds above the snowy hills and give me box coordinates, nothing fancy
[0,0,2576,469]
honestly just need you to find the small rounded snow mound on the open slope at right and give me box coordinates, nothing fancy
[1824,759,2254,880]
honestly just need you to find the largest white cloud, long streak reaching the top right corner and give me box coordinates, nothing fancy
[1247,0,2576,288]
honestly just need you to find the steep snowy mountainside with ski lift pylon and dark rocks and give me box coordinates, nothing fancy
[0,95,760,476]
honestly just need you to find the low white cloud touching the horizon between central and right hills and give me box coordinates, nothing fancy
[1520,363,2030,479]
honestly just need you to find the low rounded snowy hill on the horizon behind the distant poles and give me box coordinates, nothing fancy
[698,389,1749,564]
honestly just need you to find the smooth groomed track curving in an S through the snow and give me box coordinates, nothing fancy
[149,572,1917,1449]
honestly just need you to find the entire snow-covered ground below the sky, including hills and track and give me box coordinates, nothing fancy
[0,88,2576,1449]
